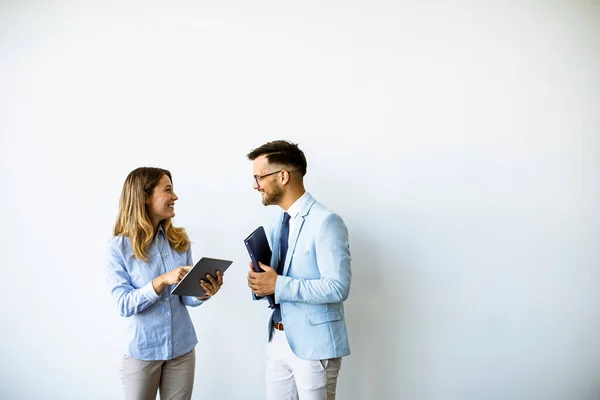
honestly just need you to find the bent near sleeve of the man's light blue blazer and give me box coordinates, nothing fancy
[275,213,352,304]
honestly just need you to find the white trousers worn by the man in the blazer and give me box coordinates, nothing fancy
[265,329,342,400]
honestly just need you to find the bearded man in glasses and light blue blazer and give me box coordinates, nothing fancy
[248,140,351,400]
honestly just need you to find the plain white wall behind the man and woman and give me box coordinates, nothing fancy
[0,0,600,400]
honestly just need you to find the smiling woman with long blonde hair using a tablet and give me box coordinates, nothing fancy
[108,168,223,399]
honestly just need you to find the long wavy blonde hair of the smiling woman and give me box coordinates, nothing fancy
[113,167,190,262]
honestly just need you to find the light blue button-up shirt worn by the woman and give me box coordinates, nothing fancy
[107,227,203,360]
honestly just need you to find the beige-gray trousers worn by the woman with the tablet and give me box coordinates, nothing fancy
[119,350,196,400]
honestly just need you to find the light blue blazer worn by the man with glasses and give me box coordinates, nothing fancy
[258,194,352,360]
